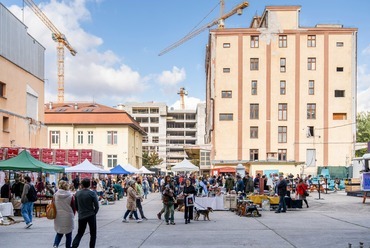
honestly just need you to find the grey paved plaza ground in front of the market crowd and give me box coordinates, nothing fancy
[0,191,370,248]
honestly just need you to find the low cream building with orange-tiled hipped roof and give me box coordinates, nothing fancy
[44,103,146,169]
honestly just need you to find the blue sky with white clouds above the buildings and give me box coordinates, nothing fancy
[0,0,370,111]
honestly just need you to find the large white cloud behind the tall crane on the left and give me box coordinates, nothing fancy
[9,0,149,103]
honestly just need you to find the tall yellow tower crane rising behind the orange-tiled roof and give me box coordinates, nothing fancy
[24,0,77,103]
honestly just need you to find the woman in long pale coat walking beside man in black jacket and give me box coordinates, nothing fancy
[53,180,75,248]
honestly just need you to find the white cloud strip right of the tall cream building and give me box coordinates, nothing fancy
[357,65,370,112]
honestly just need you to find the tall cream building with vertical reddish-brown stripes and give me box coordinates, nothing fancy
[206,6,357,174]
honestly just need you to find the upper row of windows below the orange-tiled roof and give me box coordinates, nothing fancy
[50,131,118,145]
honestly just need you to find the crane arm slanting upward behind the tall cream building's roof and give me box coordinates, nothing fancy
[158,0,249,56]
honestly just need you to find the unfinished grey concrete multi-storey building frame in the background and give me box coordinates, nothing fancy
[117,102,205,171]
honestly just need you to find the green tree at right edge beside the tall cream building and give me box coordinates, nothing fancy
[356,112,370,157]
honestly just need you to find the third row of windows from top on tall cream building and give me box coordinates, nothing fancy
[221,85,345,98]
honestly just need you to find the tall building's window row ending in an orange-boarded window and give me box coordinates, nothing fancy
[219,103,347,121]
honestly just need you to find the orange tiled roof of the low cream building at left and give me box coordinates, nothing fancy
[44,103,145,134]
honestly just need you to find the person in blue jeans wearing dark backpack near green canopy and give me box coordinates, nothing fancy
[21,176,37,228]
